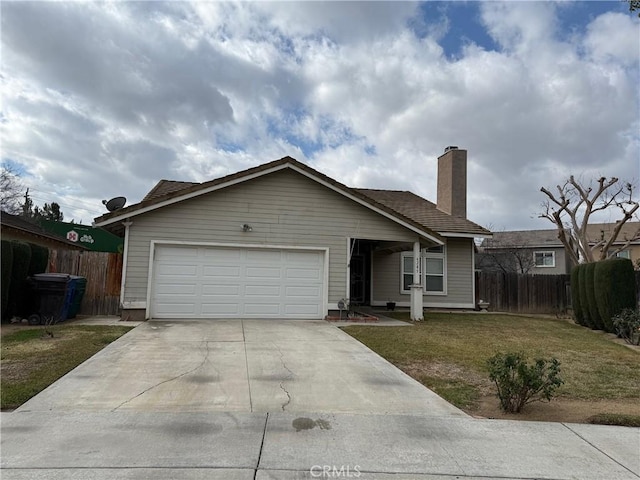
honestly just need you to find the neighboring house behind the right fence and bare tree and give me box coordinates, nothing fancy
[476,222,640,275]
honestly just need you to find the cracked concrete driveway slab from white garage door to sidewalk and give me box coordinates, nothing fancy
[17,320,466,417]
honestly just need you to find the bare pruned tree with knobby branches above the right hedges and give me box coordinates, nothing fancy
[539,175,640,264]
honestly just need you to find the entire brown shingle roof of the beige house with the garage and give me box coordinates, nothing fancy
[95,157,491,236]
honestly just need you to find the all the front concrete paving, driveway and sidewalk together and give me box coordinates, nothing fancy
[5,321,640,480]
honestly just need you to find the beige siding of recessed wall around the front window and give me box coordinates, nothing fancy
[371,238,475,308]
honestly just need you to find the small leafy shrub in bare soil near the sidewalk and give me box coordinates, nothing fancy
[487,353,564,413]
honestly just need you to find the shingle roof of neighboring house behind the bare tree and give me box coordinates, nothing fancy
[482,222,640,248]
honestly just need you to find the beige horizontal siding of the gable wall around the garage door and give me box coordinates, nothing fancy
[124,170,424,308]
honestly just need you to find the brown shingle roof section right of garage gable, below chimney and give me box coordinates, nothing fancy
[354,188,491,236]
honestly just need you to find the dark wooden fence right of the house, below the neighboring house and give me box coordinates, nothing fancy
[476,272,571,314]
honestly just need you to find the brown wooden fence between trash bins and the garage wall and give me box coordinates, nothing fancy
[48,249,122,315]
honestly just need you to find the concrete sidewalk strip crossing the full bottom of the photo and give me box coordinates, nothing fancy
[0,411,640,480]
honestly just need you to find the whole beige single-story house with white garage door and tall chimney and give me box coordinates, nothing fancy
[94,147,491,319]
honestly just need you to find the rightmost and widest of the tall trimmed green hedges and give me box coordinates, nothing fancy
[594,258,636,333]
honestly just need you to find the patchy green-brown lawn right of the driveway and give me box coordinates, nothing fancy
[344,312,640,422]
